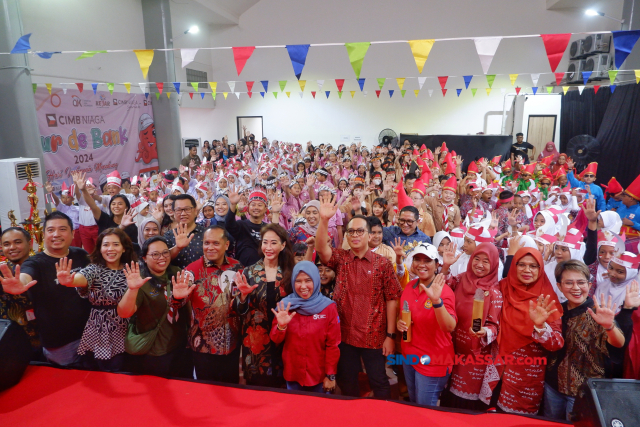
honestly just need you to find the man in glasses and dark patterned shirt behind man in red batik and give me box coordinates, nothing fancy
[164,194,204,268]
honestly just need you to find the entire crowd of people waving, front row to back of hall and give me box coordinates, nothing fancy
[0,133,640,419]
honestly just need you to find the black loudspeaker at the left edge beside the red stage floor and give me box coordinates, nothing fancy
[0,319,31,391]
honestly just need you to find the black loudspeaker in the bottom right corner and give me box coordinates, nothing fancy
[572,378,640,427]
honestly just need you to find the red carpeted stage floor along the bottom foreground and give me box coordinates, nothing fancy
[0,366,566,427]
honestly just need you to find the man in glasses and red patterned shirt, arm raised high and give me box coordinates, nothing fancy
[316,195,402,398]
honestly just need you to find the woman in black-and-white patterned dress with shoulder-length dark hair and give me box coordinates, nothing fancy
[56,228,138,371]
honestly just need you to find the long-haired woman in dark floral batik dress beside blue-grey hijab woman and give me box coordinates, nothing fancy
[233,224,295,387]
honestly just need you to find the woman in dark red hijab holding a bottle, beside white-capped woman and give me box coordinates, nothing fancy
[442,243,502,410]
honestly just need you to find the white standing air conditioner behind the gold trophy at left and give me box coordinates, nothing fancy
[0,157,45,234]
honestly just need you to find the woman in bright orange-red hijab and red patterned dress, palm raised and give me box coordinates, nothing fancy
[480,246,564,415]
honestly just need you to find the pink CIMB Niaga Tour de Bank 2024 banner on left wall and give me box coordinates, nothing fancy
[34,88,158,193]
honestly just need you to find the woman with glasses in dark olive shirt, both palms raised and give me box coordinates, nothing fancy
[118,236,193,377]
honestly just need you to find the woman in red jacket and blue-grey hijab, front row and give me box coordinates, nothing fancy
[271,261,340,393]
